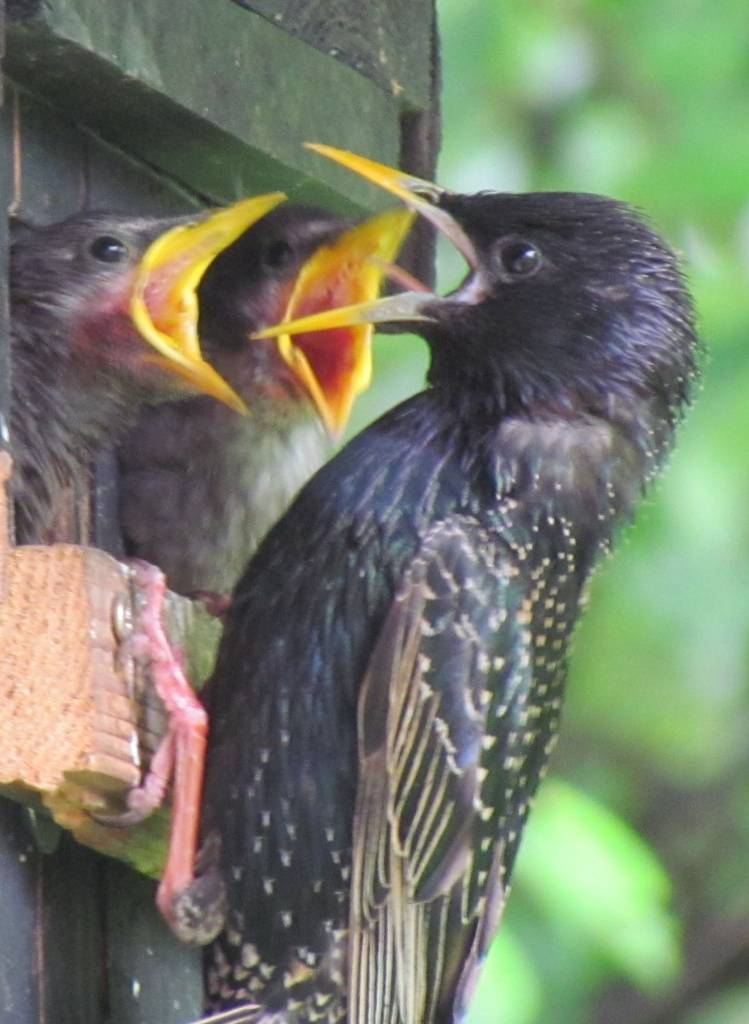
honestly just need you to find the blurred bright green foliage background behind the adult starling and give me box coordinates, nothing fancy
[352,0,749,1024]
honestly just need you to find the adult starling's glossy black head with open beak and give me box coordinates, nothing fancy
[260,146,697,456]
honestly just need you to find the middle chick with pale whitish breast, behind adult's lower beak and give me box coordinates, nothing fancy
[120,205,413,594]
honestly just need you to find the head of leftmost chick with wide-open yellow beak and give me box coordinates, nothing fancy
[10,194,284,409]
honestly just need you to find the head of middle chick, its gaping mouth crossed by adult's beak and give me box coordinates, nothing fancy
[198,205,414,434]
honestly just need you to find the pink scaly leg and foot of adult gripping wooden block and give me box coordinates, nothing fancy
[97,561,208,937]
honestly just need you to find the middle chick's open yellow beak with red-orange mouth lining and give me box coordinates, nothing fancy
[274,210,414,435]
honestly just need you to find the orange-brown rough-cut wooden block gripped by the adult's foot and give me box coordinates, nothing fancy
[0,453,219,874]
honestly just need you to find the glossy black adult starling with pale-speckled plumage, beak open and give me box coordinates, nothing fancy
[177,146,697,1024]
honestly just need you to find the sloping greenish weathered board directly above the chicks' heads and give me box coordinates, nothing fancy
[5,0,402,212]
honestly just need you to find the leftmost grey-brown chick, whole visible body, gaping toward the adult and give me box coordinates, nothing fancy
[9,194,284,543]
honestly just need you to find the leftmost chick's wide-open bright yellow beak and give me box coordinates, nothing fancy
[130,193,286,413]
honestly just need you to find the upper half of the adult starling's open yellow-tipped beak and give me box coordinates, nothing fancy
[304,142,478,270]
